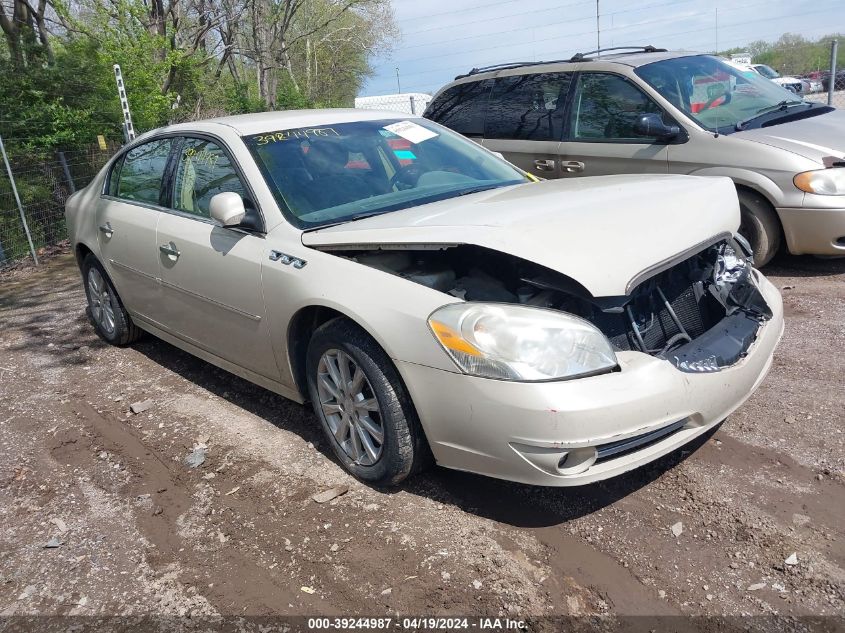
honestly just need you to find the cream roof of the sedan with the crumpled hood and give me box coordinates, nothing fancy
[155,108,420,136]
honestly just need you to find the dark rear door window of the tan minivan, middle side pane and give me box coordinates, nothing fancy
[484,73,572,141]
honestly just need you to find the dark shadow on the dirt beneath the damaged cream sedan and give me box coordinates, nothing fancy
[133,335,713,527]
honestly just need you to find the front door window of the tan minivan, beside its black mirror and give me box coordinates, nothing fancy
[569,73,662,141]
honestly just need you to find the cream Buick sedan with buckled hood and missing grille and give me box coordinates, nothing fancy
[67,110,783,486]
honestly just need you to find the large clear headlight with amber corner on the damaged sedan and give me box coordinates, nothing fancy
[428,303,616,381]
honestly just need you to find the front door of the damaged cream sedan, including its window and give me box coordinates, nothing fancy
[157,136,279,379]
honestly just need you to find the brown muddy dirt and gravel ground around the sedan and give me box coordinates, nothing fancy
[0,249,845,628]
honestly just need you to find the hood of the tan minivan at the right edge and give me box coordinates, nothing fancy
[734,110,845,163]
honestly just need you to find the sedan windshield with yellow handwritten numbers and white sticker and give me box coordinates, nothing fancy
[244,119,528,229]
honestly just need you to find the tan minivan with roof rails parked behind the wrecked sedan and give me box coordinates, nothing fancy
[424,47,845,266]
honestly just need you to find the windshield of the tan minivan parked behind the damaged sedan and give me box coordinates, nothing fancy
[636,55,802,134]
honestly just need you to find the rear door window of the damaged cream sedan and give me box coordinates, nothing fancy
[114,138,173,204]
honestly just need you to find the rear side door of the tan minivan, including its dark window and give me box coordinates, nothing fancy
[482,72,572,178]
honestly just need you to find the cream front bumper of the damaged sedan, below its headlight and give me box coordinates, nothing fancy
[397,274,783,486]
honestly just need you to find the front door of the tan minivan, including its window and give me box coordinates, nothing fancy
[560,72,674,177]
